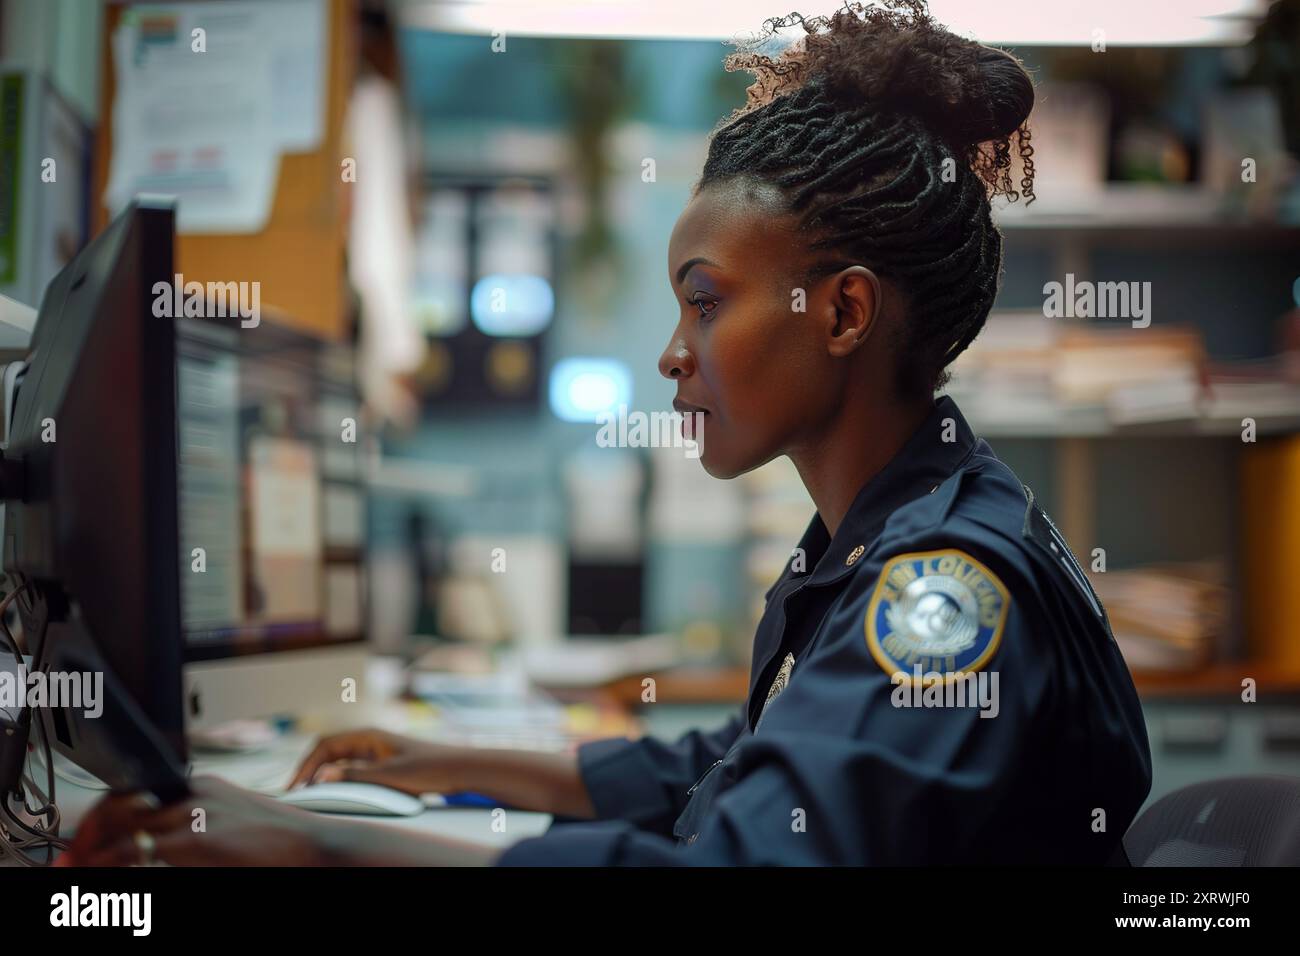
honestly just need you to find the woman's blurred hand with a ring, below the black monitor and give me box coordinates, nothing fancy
[55,777,332,866]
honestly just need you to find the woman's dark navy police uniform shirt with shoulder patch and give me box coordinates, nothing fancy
[501,397,1151,865]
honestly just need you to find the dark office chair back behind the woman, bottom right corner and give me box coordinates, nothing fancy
[1123,777,1300,866]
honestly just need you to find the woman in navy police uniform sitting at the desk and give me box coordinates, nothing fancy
[70,3,1151,865]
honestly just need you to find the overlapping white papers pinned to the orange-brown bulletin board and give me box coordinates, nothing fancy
[104,0,326,234]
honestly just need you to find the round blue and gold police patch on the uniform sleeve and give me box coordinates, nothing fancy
[863,549,1011,683]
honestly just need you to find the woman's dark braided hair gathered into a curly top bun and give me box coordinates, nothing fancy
[694,0,1034,394]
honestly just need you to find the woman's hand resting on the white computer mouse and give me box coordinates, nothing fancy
[289,728,467,796]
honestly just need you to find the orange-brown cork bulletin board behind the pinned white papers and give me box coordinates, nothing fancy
[91,0,358,339]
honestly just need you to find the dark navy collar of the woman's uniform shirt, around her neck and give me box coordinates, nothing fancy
[798,395,978,585]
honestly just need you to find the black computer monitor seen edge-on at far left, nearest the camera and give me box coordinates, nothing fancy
[0,198,186,796]
